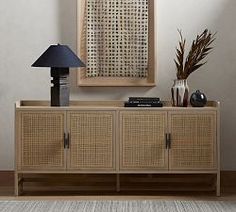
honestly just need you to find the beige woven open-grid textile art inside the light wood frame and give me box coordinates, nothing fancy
[84,0,148,78]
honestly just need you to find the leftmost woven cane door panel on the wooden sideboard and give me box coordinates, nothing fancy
[21,112,64,170]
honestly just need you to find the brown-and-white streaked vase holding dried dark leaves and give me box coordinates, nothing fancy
[171,79,189,107]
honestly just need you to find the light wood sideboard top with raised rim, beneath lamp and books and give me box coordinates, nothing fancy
[15,100,220,110]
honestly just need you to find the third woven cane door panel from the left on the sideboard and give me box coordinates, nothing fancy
[120,111,168,170]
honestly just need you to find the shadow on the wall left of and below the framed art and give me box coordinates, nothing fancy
[58,0,154,99]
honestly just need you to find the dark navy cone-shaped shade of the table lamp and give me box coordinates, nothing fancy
[32,44,85,68]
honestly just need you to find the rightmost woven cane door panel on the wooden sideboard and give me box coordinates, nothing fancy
[170,113,216,169]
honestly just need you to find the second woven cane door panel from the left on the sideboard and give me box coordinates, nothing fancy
[69,111,114,170]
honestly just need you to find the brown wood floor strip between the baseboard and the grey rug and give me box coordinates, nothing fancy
[0,186,236,201]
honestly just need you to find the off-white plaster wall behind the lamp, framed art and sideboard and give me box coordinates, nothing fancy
[0,0,236,170]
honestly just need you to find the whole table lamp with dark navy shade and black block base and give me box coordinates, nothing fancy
[32,44,85,106]
